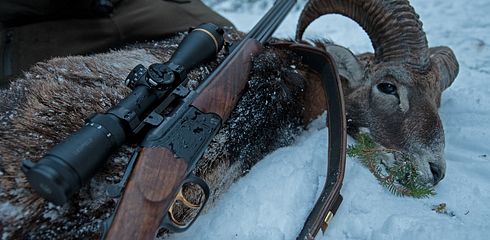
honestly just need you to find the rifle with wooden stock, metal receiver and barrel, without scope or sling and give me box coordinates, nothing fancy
[105,0,296,239]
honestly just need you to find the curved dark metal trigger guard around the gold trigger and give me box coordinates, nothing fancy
[160,175,210,232]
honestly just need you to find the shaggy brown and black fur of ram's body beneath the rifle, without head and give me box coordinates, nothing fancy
[0,31,304,239]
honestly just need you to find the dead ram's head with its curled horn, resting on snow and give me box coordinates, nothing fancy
[296,0,459,185]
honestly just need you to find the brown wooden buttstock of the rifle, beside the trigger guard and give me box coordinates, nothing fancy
[106,148,188,240]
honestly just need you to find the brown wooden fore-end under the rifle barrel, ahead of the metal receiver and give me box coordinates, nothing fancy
[192,39,262,121]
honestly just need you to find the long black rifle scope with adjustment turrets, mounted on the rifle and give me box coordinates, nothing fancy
[22,23,224,205]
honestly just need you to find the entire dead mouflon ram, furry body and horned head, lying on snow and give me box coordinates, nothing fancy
[0,0,458,239]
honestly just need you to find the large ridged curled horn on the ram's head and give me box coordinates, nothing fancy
[296,0,429,71]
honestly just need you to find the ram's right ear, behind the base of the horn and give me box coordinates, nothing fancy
[429,47,459,91]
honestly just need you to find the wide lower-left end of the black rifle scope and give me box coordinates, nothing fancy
[22,114,126,205]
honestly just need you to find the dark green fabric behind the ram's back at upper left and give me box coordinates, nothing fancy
[0,0,232,88]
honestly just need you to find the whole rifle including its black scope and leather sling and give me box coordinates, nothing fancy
[23,1,345,239]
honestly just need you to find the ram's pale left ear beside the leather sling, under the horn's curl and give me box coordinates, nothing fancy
[325,45,364,89]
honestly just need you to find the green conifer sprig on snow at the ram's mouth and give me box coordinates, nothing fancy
[347,133,435,198]
